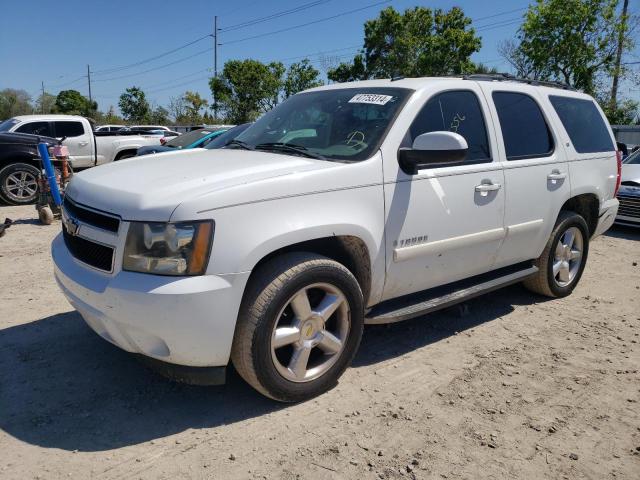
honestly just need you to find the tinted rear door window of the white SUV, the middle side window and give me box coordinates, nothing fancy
[493,92,553,160]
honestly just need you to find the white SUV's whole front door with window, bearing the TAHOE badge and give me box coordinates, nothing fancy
[382,87,505,300]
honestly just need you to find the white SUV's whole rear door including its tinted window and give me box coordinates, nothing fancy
[481,82,571,268]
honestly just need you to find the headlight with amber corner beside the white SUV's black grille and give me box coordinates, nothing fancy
[122,221,213,275]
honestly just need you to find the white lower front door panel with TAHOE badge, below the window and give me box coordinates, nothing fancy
[384,165,504,299]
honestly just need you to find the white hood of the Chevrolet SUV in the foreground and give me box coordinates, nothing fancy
[66,149,345,222]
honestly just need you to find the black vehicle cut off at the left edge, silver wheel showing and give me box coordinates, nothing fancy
[0,133,58,205]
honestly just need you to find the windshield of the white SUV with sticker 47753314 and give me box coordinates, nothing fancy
[232,88,412,161]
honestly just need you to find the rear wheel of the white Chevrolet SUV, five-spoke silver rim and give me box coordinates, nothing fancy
[524,212,589,297]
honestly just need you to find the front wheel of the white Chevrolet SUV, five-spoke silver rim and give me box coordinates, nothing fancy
[231,253,364,402]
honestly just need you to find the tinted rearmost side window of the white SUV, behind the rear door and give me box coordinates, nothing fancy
[549,95,615,153]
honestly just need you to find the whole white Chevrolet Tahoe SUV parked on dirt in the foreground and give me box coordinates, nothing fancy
[52,76,619,401]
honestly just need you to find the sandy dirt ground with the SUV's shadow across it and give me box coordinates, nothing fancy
[0,203,640,480]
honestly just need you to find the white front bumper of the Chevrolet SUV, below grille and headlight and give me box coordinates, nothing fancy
[51,234,249,367]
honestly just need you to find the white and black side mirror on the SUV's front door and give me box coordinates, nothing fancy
[398,132,469,175]
